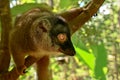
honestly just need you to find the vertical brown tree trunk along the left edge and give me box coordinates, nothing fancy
[0,0,12,73]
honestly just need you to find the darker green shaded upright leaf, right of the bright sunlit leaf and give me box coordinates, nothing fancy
[92,44,107,80]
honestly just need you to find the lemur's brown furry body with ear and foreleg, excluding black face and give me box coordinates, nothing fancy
[9,8,61,74]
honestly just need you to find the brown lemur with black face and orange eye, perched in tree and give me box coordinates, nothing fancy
[9,8,75,80]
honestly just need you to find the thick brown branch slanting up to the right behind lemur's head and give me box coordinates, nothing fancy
[59,0,105,33]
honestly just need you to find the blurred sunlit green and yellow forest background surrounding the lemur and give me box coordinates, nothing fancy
[0,0,120,80]
